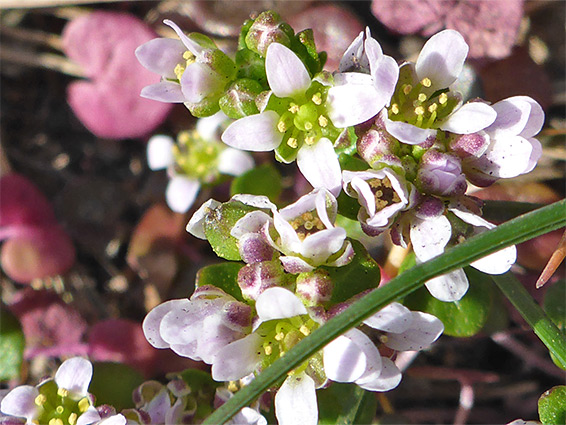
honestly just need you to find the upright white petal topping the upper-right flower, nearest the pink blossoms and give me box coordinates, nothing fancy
[416,30,469,89]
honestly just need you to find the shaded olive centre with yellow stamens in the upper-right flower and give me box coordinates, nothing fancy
[388,78,459,128]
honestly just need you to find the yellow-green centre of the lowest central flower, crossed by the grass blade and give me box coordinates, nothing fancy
[256,314,319,374]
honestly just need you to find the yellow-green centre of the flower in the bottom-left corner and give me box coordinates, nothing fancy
[34,380,92,425]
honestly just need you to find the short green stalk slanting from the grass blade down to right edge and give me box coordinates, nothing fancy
[491,272,566,368]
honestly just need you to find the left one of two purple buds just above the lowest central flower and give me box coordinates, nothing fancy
[238,260,293,300]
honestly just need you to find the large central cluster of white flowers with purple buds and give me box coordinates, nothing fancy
[137,12,544,424]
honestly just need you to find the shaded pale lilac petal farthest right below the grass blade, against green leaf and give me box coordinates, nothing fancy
[385,311,444,351]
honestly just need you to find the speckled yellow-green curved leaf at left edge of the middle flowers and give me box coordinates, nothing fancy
[204,201,255,261]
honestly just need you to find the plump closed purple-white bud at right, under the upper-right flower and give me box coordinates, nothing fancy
[417,150,467,196]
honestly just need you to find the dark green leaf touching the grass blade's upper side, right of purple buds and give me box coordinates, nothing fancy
[323,240,381,306]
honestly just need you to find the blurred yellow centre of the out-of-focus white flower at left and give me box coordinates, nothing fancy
[173,130,222,183]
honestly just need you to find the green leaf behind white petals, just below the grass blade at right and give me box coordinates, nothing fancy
[404,267,492,337]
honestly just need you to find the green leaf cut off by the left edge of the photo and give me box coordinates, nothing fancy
[0,305,26,381]
